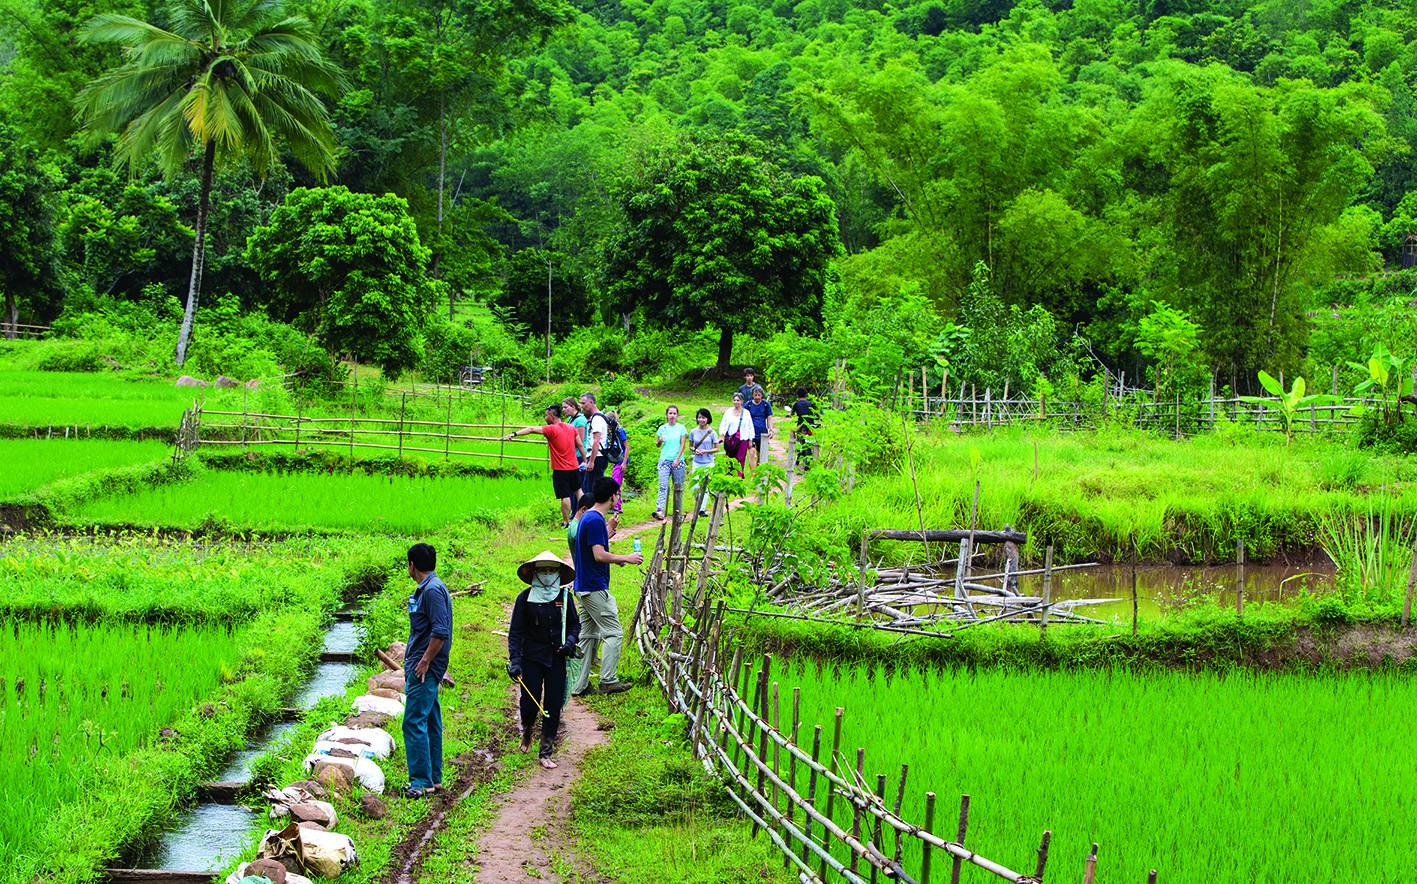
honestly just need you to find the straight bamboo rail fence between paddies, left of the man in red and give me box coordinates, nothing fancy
[174,398,546,463]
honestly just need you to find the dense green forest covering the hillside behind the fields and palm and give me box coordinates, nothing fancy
[0,0,1417,392]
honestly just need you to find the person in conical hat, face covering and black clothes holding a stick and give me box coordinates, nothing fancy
[507,551,581,769]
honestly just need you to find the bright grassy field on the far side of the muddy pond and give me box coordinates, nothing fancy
[809,428,1417,562]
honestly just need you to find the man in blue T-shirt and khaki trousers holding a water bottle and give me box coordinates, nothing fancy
[571,476,645,696]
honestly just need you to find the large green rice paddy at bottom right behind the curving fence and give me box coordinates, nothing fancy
[779,666,1417,884]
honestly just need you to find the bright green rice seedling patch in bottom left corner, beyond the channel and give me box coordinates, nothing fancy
[0,621,241,871]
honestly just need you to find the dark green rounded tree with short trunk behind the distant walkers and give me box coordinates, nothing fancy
[606,136,842,368]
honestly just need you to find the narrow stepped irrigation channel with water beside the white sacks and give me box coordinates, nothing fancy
[108,608,363,884]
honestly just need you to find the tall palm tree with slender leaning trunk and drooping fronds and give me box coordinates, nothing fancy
[78,0,343,366]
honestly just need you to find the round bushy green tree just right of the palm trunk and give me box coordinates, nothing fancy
[247,187,438,375]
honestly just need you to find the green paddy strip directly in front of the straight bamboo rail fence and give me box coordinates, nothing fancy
[69,461,551,533]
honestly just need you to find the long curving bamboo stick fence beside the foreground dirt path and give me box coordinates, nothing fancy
[629,494,1156,884]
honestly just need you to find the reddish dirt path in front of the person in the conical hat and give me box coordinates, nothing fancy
[476,700,608,884]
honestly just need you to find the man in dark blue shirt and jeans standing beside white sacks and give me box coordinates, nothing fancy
[404,544,452,798]
